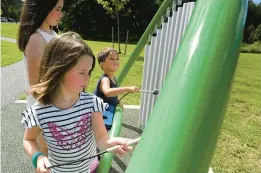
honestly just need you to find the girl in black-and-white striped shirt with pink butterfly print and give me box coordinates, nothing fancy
[22,32,132,173]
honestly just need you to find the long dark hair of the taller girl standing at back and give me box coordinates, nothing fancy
[18,0,58,51]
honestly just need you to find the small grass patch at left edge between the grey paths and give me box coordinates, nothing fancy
[1,40,22,67]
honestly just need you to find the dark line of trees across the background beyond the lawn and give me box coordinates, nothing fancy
[1,0,261,44]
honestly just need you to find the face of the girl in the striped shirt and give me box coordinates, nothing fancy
[61,55,93,94]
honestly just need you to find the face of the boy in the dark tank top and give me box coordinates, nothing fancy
[101,52,120,72]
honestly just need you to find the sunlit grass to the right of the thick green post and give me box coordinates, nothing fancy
[212,54,261,173]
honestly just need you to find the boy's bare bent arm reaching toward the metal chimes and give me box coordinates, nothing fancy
[100,77,139,97]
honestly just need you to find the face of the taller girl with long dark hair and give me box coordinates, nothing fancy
[45,0,63,26]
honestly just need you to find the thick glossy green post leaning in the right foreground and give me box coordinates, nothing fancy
[126,0,248,173]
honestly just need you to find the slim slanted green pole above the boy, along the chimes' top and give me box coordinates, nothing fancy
[117,0,173,85]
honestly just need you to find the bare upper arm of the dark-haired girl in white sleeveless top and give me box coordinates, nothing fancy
[24,32,47,86]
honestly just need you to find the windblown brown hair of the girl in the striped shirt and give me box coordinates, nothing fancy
[28,32,95,105]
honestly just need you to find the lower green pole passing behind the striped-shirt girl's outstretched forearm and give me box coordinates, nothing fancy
[97,106,122,173]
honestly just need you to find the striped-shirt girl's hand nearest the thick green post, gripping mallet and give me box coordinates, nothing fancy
[108,137,133,157]
